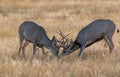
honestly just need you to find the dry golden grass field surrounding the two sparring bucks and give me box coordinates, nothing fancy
[0,0,120,77]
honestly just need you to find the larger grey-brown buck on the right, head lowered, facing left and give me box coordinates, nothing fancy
[60,19,119,58]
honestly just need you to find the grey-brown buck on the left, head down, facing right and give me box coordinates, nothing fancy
[18,21,59,57]
